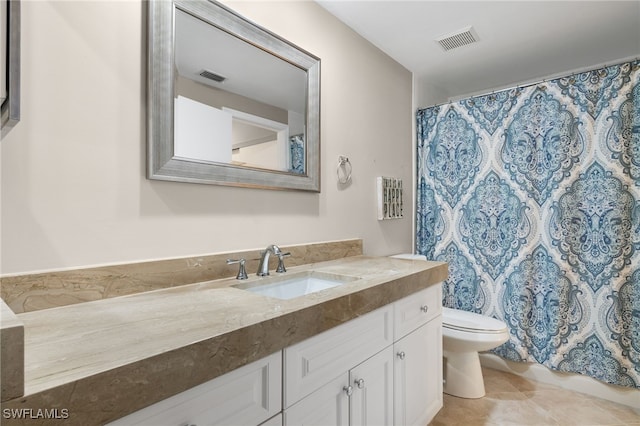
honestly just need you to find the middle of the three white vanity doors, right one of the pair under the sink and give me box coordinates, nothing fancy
[349,346,393,426]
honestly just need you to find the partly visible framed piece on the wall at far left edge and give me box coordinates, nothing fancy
[0,0,20,137]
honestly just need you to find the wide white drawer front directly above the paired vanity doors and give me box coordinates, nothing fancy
[284,305,393,407]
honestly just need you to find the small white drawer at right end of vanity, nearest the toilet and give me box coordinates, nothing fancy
[393,283,442,340]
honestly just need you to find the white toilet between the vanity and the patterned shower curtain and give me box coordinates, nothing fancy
[391,254,509,398]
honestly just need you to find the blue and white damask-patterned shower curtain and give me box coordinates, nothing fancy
[416,60,640,388]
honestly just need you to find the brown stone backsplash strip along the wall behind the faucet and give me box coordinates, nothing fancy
[0,239,363,314]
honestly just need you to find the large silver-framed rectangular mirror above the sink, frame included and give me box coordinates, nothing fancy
[147,0,320,192]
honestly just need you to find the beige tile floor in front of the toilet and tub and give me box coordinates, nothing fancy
[429,368,640,426]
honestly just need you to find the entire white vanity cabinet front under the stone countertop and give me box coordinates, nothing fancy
[109,284,442,426]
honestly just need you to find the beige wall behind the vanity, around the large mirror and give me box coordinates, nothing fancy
[0,1,413,275]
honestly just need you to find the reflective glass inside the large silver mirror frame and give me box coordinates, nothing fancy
[174,9,307,174]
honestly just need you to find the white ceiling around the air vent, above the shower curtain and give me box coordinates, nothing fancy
[316,0,640,106]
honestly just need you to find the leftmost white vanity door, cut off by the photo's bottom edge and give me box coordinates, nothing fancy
[284,373,349,426]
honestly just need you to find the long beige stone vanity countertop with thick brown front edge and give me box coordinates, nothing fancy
[2,256,447,426]
